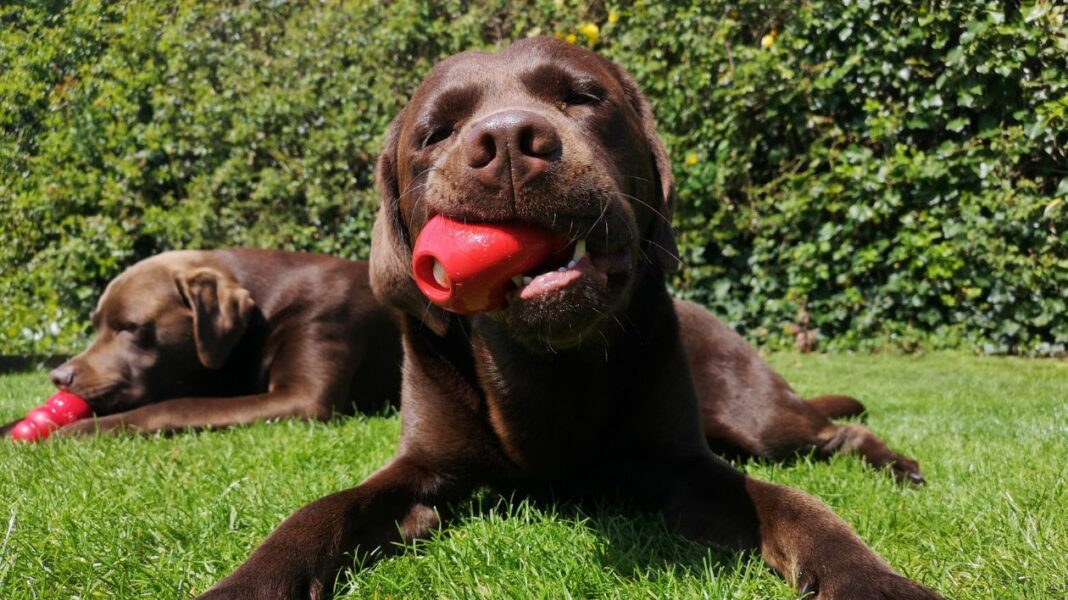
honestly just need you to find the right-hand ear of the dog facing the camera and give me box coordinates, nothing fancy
[609,62,682,272]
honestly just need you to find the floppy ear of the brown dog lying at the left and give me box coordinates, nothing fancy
[175,268,255,368]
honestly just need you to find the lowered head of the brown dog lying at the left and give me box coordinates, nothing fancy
[51,252,254,415]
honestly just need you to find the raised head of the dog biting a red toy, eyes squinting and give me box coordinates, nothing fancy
[371,37,678,346]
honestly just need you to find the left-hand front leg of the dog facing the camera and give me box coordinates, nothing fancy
[201,457,457,600]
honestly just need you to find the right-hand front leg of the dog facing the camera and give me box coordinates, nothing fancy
[645,456,939,600]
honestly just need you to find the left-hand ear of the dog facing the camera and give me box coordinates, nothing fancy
[371,111,449,335]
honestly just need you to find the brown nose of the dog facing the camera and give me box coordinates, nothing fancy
[465,110,561,190]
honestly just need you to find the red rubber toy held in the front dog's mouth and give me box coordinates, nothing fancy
[411,215,569,315]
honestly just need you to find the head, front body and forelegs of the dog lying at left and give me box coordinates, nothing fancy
[5,250,402,435]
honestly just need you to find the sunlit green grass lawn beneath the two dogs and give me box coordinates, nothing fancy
[0,354,1068,600]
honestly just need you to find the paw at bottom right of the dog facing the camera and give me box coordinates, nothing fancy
[798,569,942,600]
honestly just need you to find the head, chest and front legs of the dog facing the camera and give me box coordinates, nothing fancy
[198,38,937,599]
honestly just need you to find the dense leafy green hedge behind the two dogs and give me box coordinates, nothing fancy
[0,0,1068,354]
